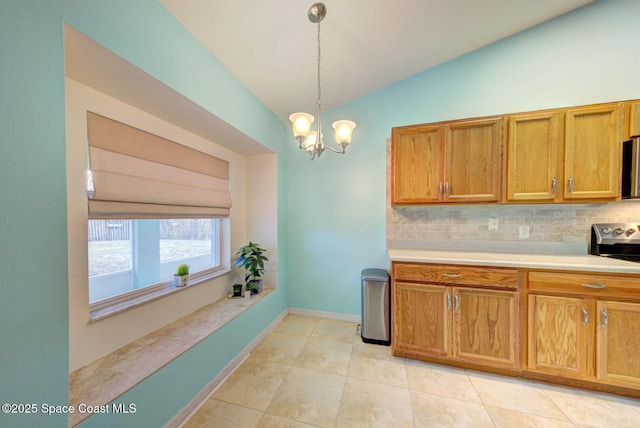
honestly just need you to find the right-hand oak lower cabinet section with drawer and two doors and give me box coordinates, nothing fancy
[525,272,640,396]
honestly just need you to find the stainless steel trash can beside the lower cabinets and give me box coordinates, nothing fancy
[360,268,391,345]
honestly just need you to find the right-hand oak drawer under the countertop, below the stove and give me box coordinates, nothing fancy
[529,272,640,298]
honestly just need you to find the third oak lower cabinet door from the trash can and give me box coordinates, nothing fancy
[528,295,594,378]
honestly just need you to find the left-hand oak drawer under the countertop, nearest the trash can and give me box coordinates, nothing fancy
[393,263,518,289]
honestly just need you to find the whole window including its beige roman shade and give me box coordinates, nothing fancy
[87,111,231,319]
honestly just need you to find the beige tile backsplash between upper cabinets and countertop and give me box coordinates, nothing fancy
[387,201,640,254]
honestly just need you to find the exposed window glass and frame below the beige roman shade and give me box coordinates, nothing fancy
[88,219,221,309]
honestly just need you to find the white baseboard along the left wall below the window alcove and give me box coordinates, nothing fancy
[170,309,289,428]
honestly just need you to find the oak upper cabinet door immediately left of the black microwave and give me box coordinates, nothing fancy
[564,104,623,199]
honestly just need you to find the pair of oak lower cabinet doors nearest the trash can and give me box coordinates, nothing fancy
[392,282,519,369]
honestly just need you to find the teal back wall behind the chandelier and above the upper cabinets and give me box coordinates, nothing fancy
[287,0,640,315]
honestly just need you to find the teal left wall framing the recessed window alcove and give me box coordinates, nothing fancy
[0,0,287,427]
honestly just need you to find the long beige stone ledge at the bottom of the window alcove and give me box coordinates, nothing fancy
[69,287,275,426]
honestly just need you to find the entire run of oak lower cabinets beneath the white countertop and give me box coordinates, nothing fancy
[391,262,640,397]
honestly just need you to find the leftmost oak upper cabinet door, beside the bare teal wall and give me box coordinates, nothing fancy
[391,125,443,204]
